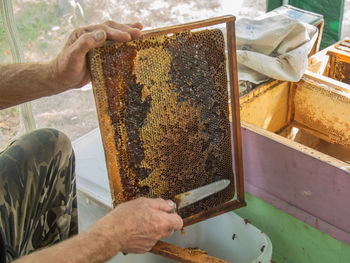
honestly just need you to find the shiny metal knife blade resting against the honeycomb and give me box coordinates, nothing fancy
[174,179,230,209]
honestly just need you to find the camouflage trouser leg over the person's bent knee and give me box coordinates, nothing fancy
[0,129,78,262]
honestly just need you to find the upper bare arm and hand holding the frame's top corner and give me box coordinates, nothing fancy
[0,21,142,109]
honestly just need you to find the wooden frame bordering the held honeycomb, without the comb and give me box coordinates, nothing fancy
[90,16,246,233]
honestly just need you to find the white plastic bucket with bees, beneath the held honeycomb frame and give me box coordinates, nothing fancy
[116,212,272,263]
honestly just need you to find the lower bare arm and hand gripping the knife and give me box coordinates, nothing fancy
[14,198,183,263]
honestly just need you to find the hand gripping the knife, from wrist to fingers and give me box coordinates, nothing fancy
[86,197,183,253]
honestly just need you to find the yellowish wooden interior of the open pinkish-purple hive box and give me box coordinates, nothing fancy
[240,54,350,163]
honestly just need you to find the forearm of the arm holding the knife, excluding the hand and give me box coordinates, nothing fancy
[14,230,119,263]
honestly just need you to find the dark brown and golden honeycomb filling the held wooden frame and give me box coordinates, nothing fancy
[89,29,234,218]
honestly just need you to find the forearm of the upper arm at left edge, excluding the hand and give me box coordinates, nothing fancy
[0,63,66,109]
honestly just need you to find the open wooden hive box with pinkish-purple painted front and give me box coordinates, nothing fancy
[240,40,350,244]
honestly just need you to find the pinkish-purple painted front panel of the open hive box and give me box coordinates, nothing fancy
[242,128,350,245]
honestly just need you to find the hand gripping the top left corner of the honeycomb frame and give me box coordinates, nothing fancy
[50,21,142,91]
